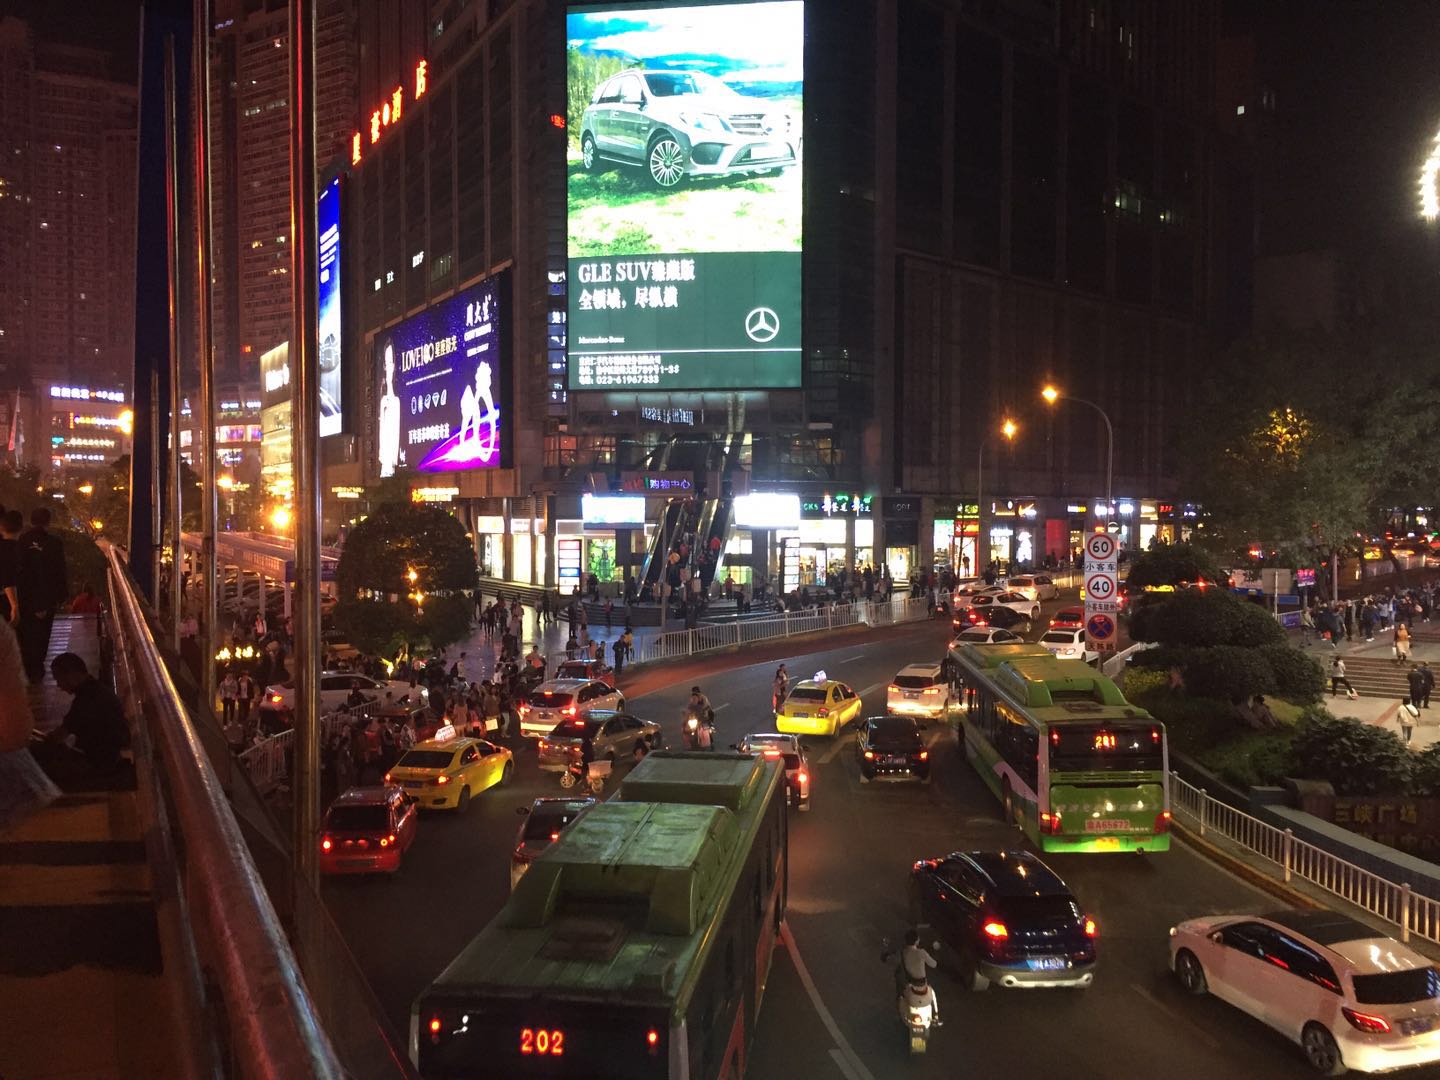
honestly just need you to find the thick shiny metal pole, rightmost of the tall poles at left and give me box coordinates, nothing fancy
[289,0,320,890]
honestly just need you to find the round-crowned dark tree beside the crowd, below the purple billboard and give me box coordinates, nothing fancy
[334,503,480,654]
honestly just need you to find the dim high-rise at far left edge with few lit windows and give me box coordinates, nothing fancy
[0,17,137,397]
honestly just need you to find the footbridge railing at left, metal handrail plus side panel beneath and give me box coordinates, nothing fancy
[108,549,344,1080]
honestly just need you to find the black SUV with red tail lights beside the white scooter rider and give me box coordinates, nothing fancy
[910,851,1094,991]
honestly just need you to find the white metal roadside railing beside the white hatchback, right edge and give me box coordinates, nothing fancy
[1171,773,1440,945]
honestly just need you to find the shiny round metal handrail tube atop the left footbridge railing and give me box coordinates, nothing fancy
[107,549,344,1080]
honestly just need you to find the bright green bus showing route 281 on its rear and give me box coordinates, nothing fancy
[949,645,1171,851]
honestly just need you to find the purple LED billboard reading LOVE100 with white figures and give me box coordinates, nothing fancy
[374,275,510,477]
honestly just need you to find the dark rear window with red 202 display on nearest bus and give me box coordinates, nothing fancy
[415,999,670,1080]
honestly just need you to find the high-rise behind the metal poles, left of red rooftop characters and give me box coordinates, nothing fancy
[210,0,356,379]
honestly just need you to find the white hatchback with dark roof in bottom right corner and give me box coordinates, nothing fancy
[1169,912,1440,1076]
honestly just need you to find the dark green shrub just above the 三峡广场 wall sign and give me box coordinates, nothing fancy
[1293,707,1414,795]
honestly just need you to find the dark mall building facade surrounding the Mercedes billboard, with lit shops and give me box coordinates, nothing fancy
[327,0,1230,589]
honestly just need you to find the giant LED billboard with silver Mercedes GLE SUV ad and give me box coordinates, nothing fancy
[566,0,805,390]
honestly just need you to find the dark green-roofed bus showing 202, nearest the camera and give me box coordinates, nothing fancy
[410,750,788,1080]
